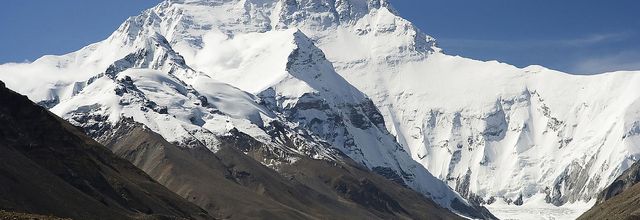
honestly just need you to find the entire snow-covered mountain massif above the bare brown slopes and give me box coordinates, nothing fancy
[0,0,640,217]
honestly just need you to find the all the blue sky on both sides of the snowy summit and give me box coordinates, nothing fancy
[0,0,640,74]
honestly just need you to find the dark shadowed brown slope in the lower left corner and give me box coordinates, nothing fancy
[0,82,211,219]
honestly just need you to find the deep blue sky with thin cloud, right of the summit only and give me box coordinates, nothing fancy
[394,0,640,74]
